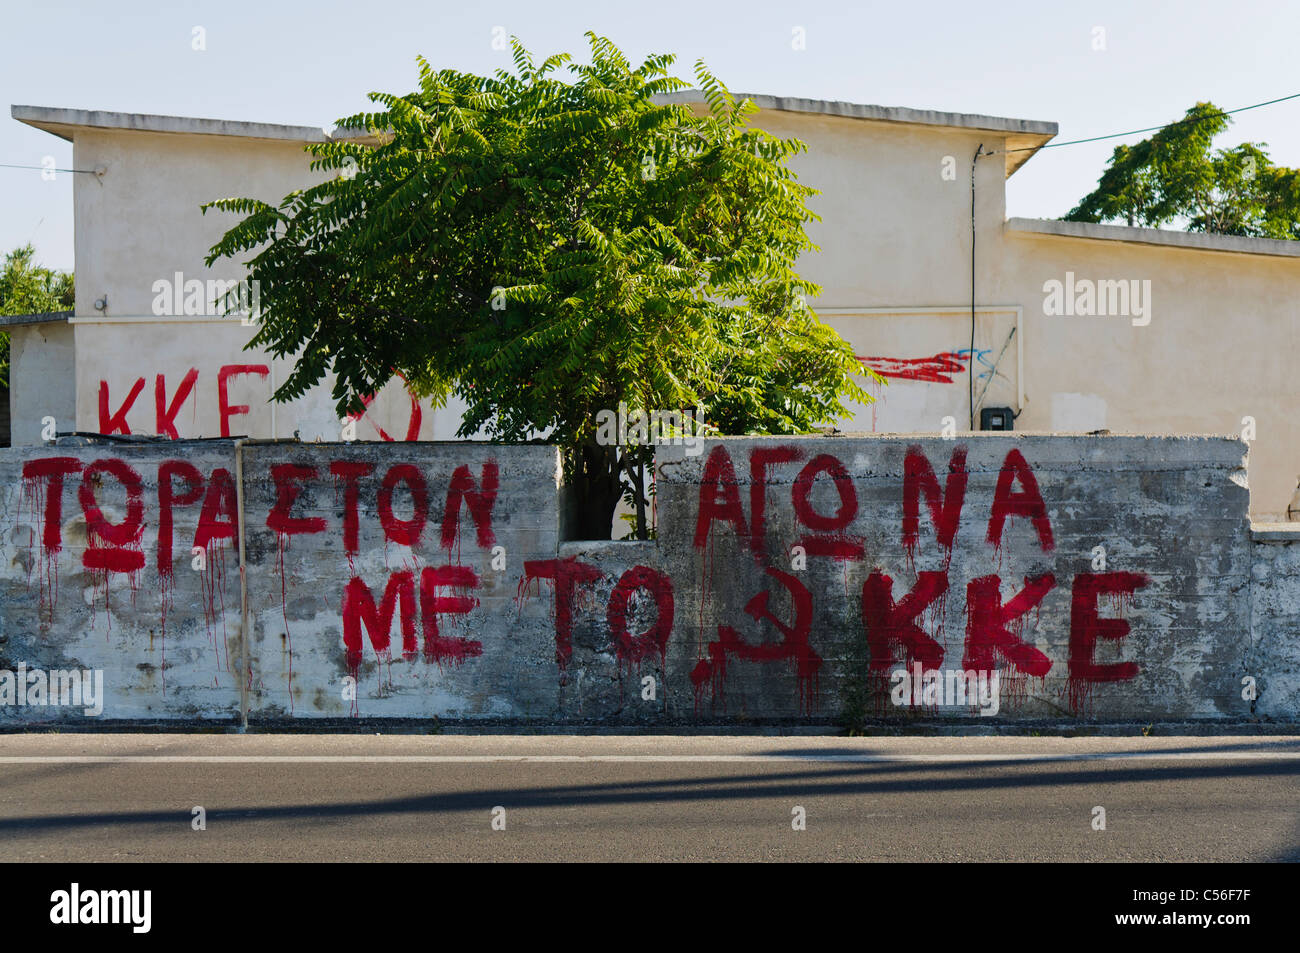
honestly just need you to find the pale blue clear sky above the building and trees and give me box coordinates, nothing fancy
[0,0,1300,268]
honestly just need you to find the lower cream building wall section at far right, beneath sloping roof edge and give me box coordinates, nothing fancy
[995,231,1300,520]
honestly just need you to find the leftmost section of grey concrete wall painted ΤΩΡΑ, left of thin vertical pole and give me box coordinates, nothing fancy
[0,441,239,723]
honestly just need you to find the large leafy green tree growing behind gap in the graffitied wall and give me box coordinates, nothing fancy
[204,34,870,538]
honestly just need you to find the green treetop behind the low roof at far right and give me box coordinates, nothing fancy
[1065,103,1300,239]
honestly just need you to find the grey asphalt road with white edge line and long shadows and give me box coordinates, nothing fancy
[0,735,1300,862]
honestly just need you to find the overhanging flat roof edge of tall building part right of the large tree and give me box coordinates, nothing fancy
[655,90,1060,176]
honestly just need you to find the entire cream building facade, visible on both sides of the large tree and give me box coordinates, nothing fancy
[23,111,1300,519]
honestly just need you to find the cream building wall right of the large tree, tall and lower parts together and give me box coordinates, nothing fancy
[755,113,1300,520]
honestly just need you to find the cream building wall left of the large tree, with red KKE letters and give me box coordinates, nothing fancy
[57,124,473,439]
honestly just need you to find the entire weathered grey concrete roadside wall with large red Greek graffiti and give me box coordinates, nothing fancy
[0,434,1279,725]
